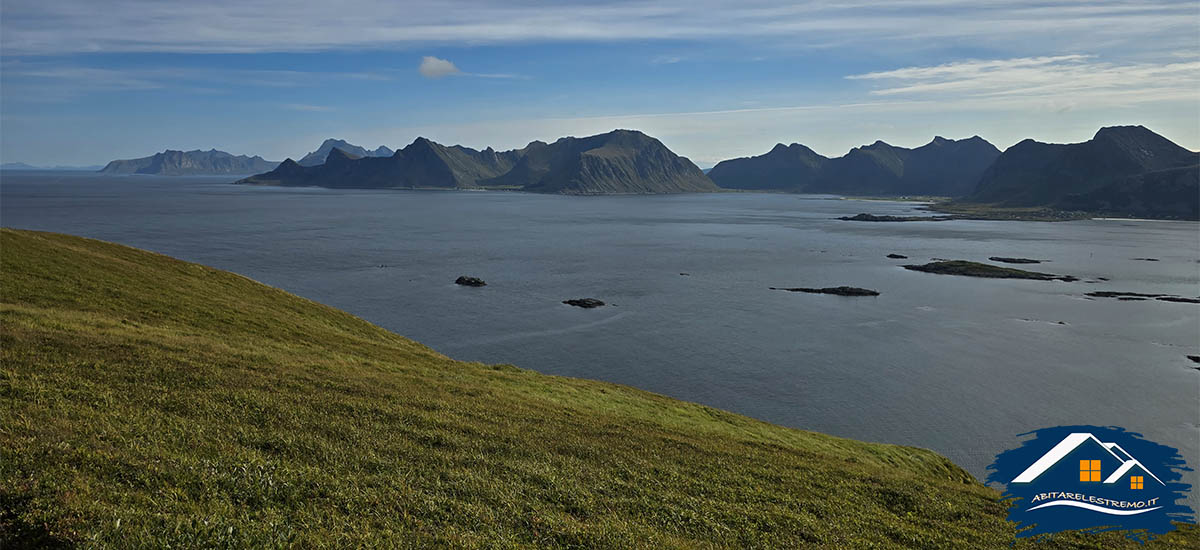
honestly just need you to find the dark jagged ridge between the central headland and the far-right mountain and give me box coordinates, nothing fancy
[708,136,1000,197]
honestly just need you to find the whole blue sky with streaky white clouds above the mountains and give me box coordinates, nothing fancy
[0,0,1200,167]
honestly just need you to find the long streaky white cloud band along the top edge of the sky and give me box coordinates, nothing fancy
[0,0,1195,55]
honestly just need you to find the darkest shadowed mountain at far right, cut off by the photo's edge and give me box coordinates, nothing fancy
[959,126,1200,219]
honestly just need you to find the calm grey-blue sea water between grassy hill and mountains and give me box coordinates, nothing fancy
[0,173,1200,483]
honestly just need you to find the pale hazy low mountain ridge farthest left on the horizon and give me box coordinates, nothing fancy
[100,149,278,175]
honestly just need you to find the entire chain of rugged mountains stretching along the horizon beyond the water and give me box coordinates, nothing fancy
[84,126,1200,220]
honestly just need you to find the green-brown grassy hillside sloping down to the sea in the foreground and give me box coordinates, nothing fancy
[0,229,1200,549]
